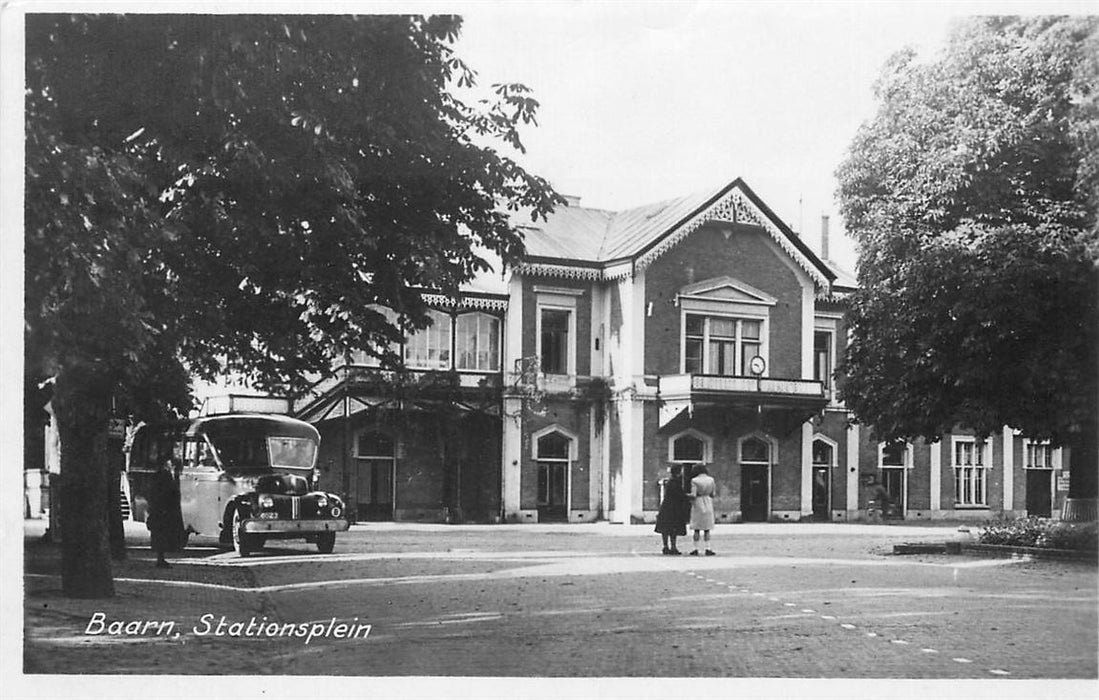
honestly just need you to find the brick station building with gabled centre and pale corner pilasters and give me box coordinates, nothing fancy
[292,179,1067,523]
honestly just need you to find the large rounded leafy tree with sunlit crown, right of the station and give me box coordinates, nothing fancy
[837,16,1099,498]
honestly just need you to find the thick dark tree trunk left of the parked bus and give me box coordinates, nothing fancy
[54,364,114,598]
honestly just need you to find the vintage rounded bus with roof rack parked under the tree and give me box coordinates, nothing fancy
[126,413,349,556]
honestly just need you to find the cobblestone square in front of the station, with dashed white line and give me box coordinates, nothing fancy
[24,524,1099,697]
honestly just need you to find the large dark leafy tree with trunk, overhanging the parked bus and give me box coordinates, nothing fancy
[25,14,558,597]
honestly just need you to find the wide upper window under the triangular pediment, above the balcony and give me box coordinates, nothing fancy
[684,313,763,376]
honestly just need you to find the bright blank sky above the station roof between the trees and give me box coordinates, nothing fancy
[443,0,1099,271]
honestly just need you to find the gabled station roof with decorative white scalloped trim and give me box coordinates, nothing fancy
[519,178,836,287]
